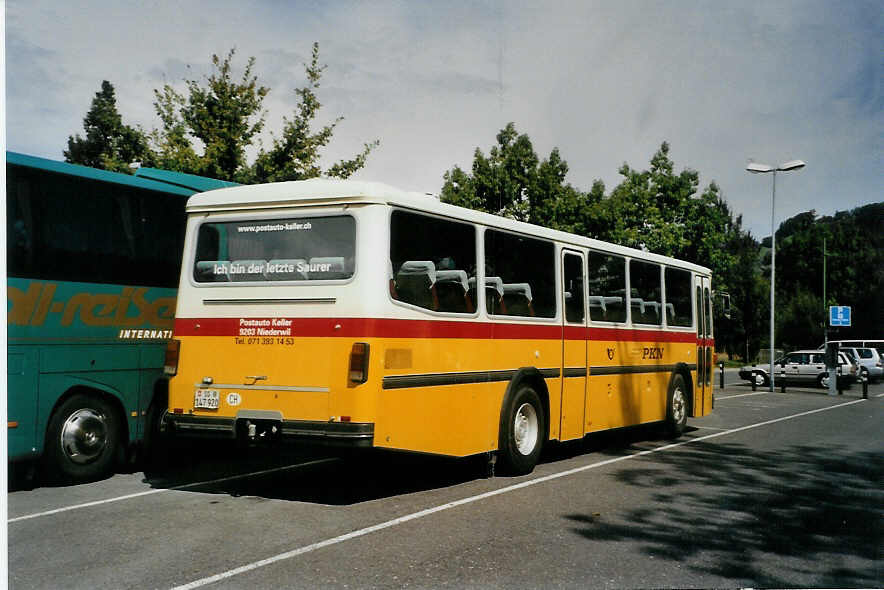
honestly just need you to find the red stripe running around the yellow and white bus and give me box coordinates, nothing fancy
[175,318,713,346]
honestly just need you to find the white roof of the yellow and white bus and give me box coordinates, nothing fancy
[187,178,711,274]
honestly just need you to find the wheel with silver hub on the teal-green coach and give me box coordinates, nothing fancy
[45,393,120,482]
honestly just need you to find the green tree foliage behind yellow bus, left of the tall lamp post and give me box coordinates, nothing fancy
[442,123,763,354]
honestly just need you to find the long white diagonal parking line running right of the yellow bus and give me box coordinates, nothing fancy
[172,399,867,590]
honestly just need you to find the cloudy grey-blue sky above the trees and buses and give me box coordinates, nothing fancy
[6,0,884,237]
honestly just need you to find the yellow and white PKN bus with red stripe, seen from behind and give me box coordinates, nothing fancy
[164,179,713,474]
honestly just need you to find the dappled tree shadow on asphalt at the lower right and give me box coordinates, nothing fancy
[566,442,884,588]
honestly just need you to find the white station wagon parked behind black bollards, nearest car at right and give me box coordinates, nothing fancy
[740,350,857,388]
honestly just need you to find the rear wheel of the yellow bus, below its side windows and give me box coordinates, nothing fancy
[498,385,546,475]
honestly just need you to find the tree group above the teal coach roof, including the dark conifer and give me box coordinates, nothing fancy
[73,43,379,183]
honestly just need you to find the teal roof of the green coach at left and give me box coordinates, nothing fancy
[6,151,235,196]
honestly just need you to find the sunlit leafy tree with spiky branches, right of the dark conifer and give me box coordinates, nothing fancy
[151,43,379,183]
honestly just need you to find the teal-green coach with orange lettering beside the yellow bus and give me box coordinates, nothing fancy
[6,152,234,482]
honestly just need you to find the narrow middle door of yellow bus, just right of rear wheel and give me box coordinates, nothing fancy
[560,250,587,440]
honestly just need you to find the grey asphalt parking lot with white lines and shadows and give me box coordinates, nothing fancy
[8,382,884,589]
